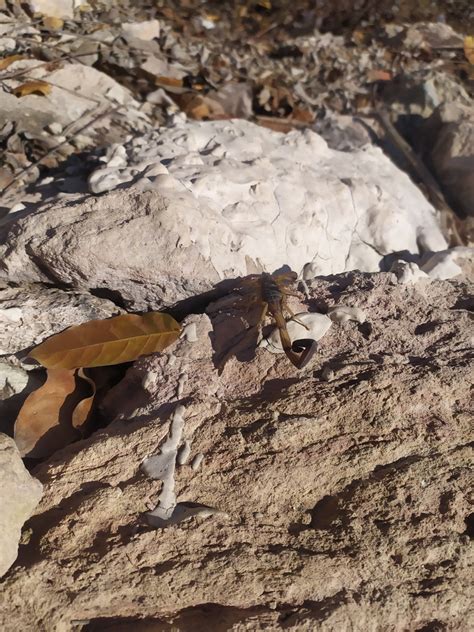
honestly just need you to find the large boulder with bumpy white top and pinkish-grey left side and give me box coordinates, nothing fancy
[0,120,446,309]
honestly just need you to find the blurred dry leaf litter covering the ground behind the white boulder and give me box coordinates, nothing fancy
[0,0,474,215]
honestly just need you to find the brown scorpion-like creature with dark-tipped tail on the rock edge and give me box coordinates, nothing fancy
[231,272,317,369]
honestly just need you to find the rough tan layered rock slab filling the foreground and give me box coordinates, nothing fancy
[0,273,473,632]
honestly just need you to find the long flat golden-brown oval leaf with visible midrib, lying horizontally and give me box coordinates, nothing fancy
[30,312,181,369]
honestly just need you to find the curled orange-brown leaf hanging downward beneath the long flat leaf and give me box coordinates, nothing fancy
[14,369,78,458]
